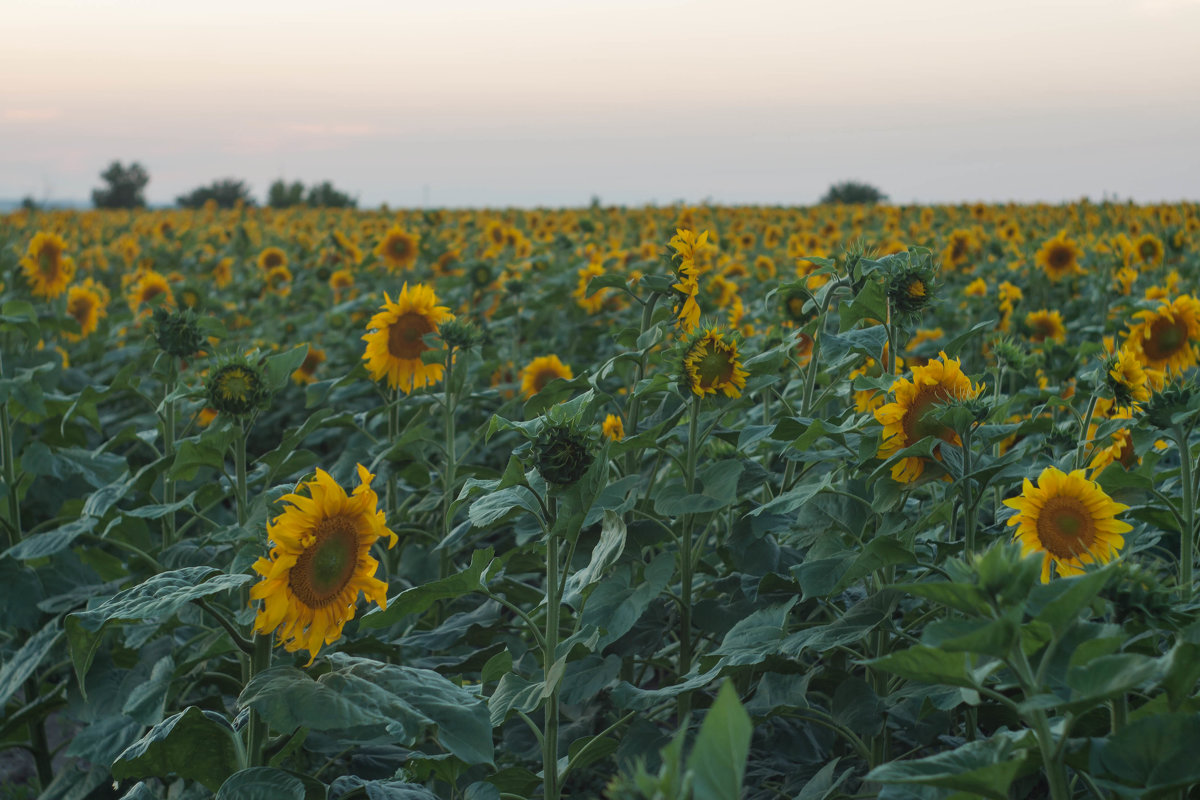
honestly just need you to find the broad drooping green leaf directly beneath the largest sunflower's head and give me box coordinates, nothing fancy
[238,654,493,764]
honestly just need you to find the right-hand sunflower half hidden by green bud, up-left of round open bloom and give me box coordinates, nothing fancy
[875,353,983,483]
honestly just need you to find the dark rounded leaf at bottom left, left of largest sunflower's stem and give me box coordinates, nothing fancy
[113,705,245,792]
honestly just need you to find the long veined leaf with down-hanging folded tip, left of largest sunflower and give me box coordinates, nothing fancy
[66,566,251,692]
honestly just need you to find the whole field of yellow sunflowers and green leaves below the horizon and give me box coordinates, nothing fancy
[0,201,1200,800]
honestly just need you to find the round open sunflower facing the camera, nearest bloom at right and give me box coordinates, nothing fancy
[1004,467,1133,583]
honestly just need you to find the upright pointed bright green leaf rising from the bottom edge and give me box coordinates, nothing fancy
[688,681,754,800]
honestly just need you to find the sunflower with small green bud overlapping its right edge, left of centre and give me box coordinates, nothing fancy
[362,283,454,395]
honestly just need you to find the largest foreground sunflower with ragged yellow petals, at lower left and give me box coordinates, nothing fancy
[250,464,396,664]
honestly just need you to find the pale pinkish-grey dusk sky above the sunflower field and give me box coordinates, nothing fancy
[0,0,1200,207]
